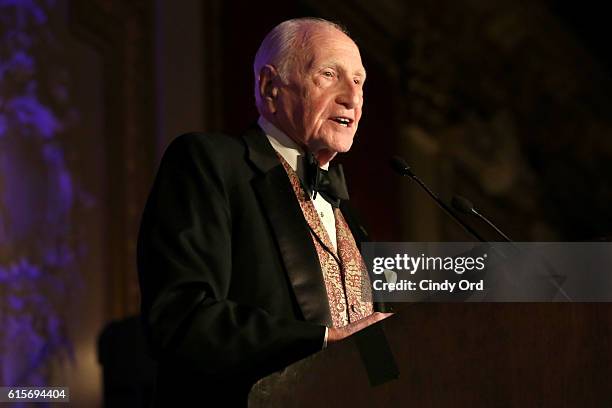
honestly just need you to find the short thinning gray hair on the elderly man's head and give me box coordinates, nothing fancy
[253,17,349,112]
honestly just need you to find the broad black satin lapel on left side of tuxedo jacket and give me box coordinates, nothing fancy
[243,127,331,325]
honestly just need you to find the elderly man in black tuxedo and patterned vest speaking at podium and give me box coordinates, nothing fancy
[138,18,386,405]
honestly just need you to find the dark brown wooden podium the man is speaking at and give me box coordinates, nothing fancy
[249,303,612,408]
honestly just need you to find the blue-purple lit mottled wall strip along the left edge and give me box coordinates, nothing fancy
[0,0,80,392]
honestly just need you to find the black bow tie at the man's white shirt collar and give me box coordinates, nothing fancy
[304,152,349,208]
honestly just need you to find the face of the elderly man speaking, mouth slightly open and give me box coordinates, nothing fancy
[275,28,365,162]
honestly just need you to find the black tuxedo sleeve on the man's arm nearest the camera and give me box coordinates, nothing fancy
[138,135,325,377]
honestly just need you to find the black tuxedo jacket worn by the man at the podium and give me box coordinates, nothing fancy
[138,127,366,405]
